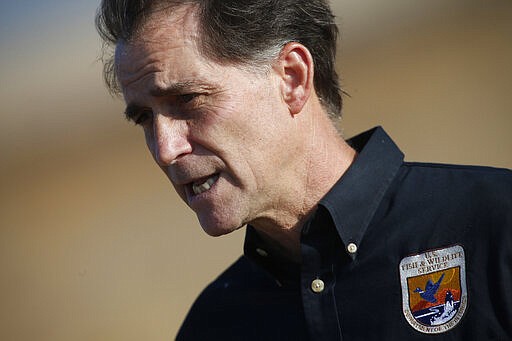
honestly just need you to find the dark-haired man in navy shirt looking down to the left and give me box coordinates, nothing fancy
[97,0,512,340]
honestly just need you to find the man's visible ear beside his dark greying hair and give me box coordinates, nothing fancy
[274,42,314,115]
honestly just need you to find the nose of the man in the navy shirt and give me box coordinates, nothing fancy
[148,114,192,167]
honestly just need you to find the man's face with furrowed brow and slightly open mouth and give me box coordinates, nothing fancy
[116,6,295,235]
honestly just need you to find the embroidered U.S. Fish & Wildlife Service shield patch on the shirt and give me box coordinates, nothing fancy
[400,245,468,334]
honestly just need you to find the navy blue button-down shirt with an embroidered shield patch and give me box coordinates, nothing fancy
[177,128,512,340]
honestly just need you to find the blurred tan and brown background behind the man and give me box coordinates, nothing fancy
[0,0,512,341]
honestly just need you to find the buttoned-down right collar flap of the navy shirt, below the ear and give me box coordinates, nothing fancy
[319,127,404,259]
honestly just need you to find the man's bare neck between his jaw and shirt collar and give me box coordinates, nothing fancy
[251,101,356,262]
